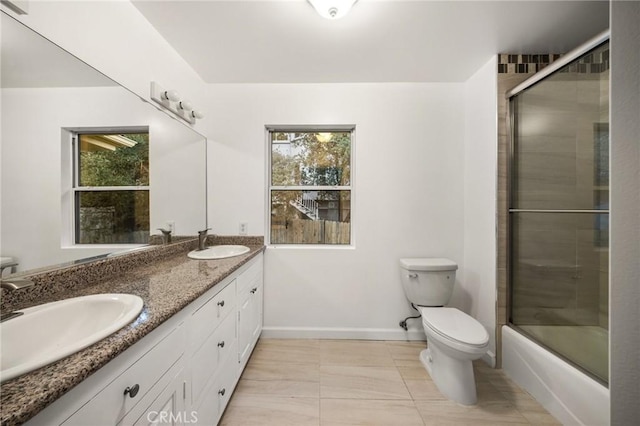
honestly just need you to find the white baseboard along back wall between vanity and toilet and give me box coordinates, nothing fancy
[261,326,426,341]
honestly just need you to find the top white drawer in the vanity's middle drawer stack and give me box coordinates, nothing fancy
[189,280,236,352]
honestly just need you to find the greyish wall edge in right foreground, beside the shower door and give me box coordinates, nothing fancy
[609,0,640,425]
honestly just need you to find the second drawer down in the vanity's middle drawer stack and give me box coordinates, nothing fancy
[191,315,237,402]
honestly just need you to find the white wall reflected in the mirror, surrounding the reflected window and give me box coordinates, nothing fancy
[0,86,206,271]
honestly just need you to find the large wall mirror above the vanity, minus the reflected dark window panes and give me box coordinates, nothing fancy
[0,12,207,277]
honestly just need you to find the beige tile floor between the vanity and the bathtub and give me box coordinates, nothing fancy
[220,339,559,426]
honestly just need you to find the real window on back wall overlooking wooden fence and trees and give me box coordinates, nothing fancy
[268,127,354,245]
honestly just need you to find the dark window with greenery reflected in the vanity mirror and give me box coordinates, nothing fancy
[72,133,149,244]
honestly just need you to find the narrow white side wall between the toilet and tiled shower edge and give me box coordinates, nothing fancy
[458,56,498,362]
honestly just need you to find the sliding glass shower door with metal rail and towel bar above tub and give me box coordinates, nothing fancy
[508,36,609,386]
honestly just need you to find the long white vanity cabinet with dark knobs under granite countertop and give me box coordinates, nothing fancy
[22,254,263,426]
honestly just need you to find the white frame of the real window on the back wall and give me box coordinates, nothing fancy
[265,124,356,249]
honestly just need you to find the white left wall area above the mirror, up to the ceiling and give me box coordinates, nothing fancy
[1,0,204,128]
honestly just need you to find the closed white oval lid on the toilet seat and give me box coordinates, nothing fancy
[420,307,489,346]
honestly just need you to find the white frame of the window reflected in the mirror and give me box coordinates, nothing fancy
[62,126,151,249]
